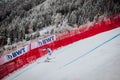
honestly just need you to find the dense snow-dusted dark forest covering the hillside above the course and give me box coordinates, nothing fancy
[0,0,120,46]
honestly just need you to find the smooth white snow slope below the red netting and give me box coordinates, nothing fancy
[4,27,120,80]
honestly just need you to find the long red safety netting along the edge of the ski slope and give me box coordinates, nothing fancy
[0,14,120,79]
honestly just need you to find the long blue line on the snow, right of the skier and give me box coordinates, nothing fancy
[63,33,120,67]
